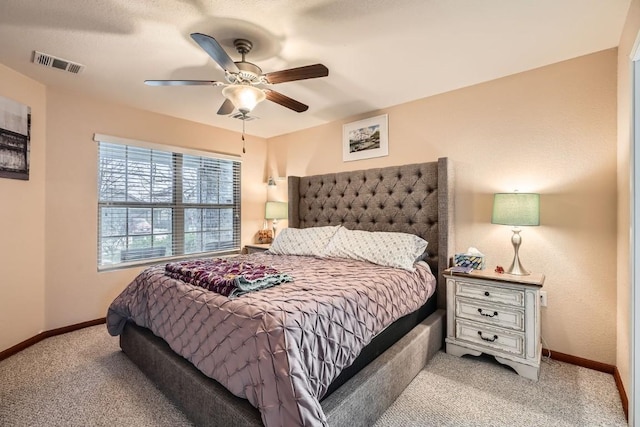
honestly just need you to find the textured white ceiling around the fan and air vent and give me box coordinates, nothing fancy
[0,0,630,137]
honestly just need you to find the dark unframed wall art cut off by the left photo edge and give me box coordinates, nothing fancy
[0,96,31,180]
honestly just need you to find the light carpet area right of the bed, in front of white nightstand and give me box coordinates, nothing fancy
[376,352,627,427]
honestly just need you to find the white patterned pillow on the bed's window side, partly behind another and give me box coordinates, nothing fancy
[269,225,340,257]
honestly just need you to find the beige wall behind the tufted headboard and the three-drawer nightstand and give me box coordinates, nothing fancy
[268,49,617,364]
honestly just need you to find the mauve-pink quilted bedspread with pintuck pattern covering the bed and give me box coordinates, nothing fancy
[107,253,435,427]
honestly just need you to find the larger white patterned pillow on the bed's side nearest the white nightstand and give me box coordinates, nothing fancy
[325,227,428,271]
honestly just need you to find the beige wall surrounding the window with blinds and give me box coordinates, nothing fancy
[46,86,266,329]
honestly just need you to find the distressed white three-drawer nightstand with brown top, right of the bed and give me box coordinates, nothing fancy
[444,270,544,381]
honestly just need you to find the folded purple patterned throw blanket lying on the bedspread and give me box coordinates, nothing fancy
[165,258,293,298]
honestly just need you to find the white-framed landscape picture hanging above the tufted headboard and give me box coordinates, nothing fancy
[342,114,389,162]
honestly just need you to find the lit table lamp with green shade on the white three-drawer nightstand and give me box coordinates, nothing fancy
[491,193,540,276]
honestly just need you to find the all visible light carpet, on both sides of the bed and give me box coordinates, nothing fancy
[0,325,627,427]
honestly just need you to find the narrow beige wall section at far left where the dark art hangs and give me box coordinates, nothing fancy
[0,65,47,351]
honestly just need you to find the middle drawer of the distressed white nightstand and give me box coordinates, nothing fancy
[456,298,524,331]
